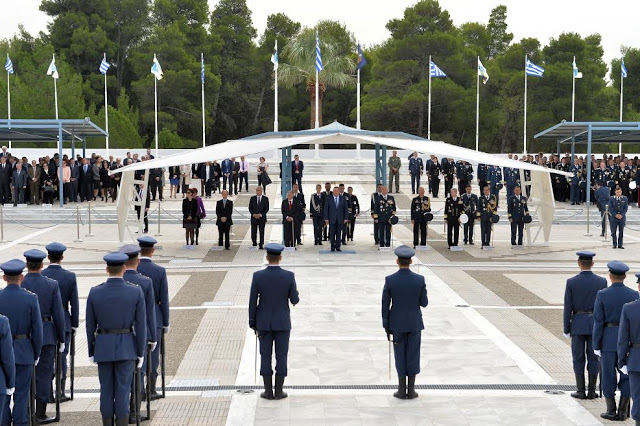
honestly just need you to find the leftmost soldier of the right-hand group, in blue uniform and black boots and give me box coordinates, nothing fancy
[563,251,607,399]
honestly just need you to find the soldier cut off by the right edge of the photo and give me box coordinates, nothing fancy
[618,274,640,425]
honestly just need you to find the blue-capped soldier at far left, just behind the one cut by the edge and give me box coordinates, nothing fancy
[0,259,37,425]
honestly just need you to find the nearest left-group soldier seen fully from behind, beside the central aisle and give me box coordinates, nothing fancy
[86,253,147,426]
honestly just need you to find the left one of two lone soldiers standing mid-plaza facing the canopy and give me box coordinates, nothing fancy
[249,245,300,399]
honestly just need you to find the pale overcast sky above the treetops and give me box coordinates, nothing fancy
[0,0,640,72]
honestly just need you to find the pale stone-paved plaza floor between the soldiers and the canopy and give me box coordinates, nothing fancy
[0,176,640,426]
